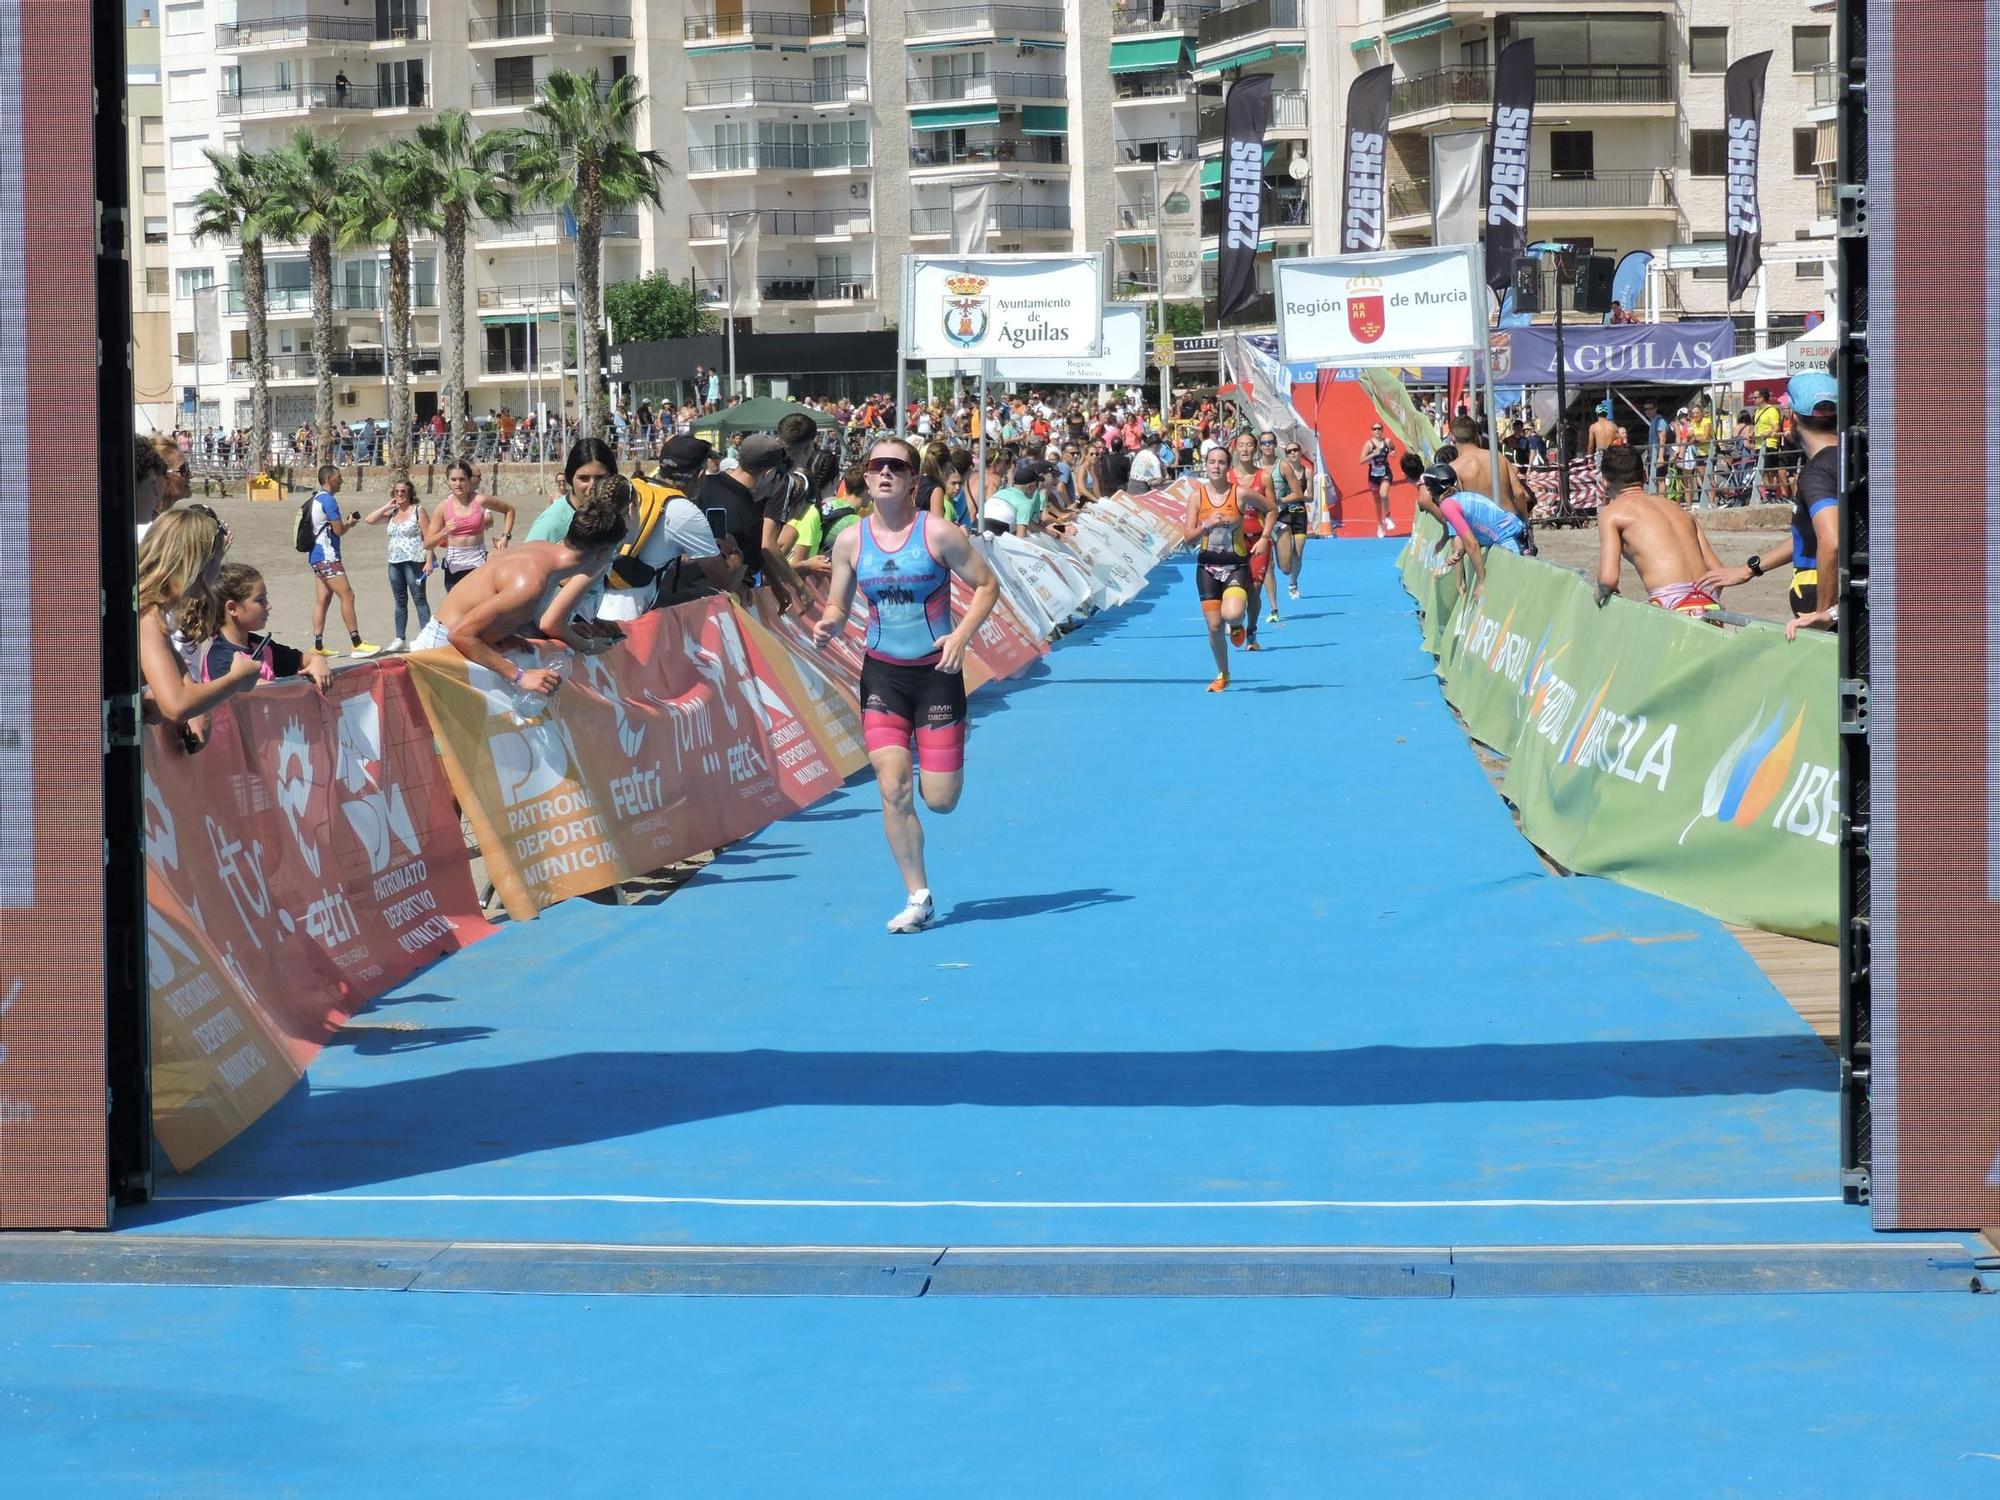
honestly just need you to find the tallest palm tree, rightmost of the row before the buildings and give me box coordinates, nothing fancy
[514,68,668,436]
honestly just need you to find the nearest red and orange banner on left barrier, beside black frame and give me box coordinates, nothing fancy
[146,662,492,1168]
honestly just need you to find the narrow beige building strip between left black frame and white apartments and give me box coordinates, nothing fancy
[126,10,180,432]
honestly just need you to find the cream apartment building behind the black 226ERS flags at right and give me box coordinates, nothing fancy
[1336,0,1832,340]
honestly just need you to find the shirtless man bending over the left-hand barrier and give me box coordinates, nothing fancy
[410,478,632,694]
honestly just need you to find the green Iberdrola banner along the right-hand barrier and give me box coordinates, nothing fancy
[1402,518,1840,942]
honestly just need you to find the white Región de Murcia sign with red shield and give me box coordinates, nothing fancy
[1272,246,1486,366]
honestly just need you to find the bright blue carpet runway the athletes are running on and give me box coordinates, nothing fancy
[0,542,2000,1500]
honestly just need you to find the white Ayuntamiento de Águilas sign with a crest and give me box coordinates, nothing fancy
[902,254,1104,360]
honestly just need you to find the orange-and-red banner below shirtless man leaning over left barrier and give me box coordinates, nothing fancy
[408,596,866,920]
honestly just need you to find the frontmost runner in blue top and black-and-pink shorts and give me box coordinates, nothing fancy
[812,438,1000,932]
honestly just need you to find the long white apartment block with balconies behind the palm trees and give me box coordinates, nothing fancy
[160,0,1136,426]
